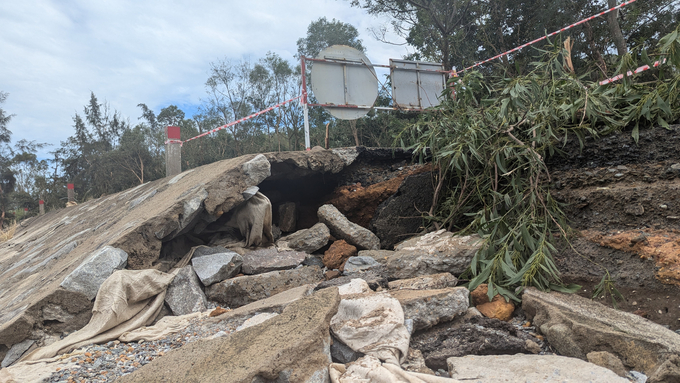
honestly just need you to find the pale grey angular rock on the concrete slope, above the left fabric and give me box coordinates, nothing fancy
[60,246,128,300]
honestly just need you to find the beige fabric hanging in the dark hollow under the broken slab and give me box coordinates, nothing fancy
[227,192,274,247]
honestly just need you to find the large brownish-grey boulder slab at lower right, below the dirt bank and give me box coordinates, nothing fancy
[522,288,680,379]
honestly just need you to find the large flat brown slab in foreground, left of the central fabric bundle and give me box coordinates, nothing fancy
[119,289,340,383]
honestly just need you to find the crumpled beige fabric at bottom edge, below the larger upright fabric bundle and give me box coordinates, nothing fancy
[328,355,460,383]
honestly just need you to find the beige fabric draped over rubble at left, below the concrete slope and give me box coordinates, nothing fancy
[22,268,184,361]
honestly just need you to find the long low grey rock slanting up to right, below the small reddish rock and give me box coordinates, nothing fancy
[205,266,323,308]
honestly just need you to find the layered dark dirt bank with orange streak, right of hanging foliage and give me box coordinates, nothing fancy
[548,125,680,329]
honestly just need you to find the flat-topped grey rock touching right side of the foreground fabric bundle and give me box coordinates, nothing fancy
[389,287,470,331]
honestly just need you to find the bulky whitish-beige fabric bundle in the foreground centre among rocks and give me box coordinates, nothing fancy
[331,292,411,366]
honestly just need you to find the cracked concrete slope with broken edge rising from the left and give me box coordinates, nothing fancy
[0,149,348,356]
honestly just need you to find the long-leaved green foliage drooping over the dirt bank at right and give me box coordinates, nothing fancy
[410,27,680,299]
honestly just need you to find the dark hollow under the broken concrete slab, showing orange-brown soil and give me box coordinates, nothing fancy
[154,151,432,270]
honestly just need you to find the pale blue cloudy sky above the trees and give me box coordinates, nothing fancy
[0,0,410,157]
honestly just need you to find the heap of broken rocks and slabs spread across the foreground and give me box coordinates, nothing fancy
[0,146,680,383]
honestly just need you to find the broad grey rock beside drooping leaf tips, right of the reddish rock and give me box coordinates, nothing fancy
[386,230,482,280]
